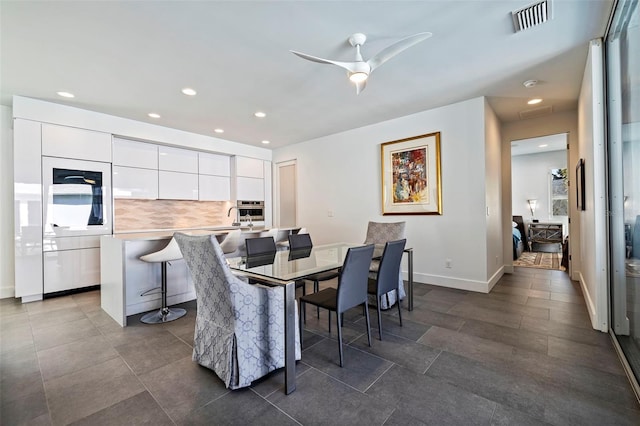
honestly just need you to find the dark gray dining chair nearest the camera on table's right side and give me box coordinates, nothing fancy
[300,244,374,367]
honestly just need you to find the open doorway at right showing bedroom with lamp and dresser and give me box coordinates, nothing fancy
[511,133,570,270]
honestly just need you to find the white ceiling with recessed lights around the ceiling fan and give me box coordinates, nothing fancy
[0,0,612,148]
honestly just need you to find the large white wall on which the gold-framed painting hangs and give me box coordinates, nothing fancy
[273,98,498,292]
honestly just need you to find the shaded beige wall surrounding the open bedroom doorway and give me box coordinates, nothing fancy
[501,111,580,274]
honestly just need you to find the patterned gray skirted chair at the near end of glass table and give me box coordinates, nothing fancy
[175,233,301,389]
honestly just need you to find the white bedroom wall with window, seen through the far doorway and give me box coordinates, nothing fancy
[511,151,575,235]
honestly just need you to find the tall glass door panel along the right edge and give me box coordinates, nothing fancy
[606,0,640,379]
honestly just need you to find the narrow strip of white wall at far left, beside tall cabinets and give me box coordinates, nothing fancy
[0,105,15,299]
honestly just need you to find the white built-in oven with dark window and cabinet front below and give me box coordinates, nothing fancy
[42,157,112,295]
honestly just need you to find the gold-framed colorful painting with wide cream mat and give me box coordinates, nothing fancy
[380,132,442,215]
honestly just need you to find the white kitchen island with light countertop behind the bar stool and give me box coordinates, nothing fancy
[100,227,267,327]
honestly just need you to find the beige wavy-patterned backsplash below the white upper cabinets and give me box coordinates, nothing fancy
[114,199,236,233]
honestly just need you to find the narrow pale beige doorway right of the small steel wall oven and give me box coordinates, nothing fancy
[276,160,298,228]
